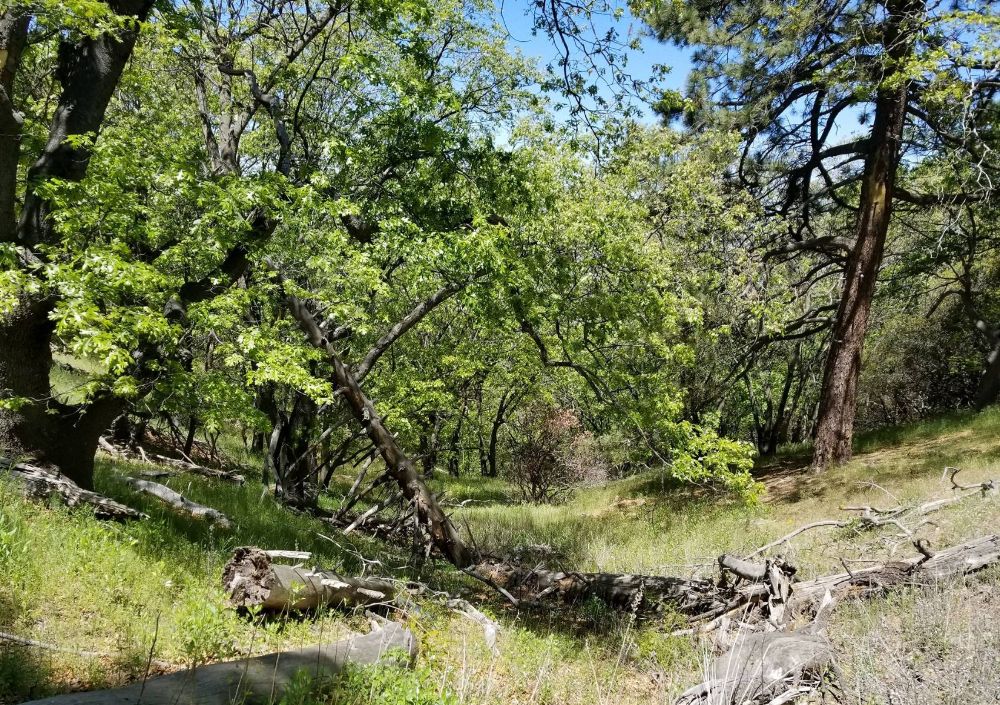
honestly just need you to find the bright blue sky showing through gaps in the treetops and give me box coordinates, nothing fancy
[496,0,691,118]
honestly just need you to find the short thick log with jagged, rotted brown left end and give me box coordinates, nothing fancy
[222,546,396,610]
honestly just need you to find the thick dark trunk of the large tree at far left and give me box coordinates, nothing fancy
[0,0,152,489]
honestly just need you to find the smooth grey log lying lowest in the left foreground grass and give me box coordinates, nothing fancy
[22,623,416,705]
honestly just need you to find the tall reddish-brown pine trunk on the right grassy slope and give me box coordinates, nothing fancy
[813,0,923,470]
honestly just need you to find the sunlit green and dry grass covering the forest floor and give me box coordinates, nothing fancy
[0,409,1000,705]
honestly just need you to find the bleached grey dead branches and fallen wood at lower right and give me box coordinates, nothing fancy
[677,468,1000,705]
